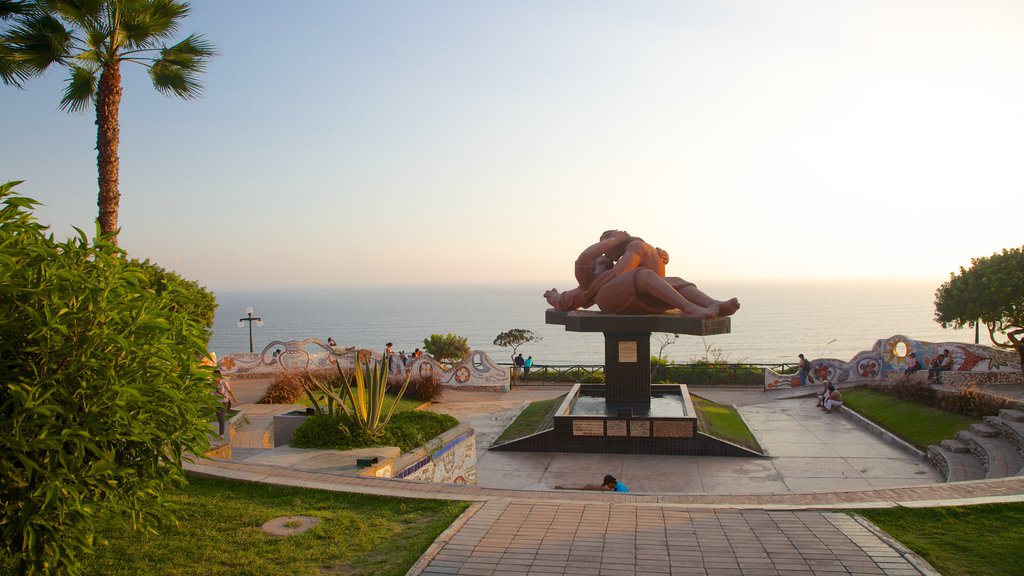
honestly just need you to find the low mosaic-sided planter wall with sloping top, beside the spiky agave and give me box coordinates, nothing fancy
[360,424,476,484]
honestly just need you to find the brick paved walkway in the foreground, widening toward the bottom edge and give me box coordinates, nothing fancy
[411,500,936,575]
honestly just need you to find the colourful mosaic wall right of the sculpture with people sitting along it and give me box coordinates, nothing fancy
[765,334,1020,389]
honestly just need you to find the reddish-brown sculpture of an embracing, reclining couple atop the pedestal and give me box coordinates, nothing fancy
[544,230,739,320]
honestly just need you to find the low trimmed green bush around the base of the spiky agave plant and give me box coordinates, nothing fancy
[291,410,459,452]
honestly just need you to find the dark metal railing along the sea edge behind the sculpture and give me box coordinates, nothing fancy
[501,363,797,387]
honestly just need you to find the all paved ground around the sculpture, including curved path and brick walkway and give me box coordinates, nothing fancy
[187,381,1024,575]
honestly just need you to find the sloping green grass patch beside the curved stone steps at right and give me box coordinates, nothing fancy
[843,388,981,450]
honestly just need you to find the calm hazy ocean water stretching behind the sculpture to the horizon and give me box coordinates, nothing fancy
[211,280,974,364]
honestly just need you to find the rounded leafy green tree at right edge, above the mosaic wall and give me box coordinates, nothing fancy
[935,248,1024,371]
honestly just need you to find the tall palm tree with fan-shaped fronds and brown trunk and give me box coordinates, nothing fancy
[0,0,214,243]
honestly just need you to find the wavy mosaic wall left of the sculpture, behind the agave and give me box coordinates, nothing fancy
[218,338,510,392]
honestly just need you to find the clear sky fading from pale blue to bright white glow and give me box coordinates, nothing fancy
[0,0,1024,290]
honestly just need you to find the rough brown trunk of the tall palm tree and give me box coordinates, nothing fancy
[96,58,121,244]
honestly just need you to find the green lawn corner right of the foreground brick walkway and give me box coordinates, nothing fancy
[860,500,1024,576]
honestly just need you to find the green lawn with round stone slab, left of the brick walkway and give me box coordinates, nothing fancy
[82,477,468,576]
